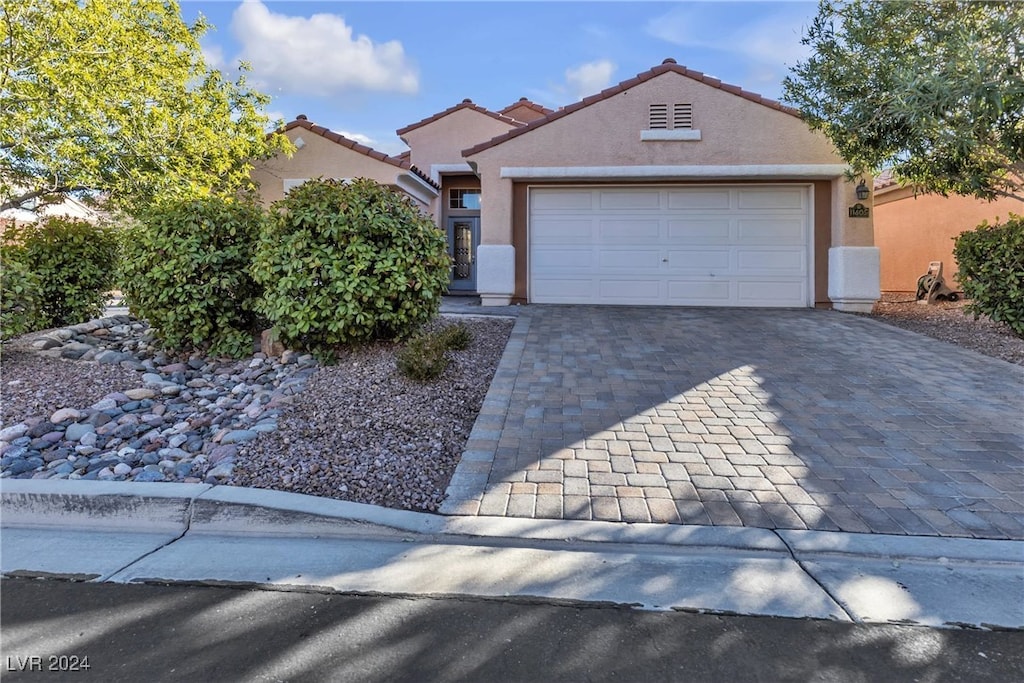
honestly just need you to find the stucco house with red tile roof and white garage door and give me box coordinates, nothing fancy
[254,59,879,311]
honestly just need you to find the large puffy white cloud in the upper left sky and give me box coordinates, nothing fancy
[231,0,420,96]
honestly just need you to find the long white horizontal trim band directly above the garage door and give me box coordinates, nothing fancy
[501,164,848,180]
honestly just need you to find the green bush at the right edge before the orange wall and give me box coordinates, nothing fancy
[953,214,1024,337]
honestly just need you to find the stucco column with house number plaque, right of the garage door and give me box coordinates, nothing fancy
[828,178,882,313]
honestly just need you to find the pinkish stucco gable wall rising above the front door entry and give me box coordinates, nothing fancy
[402,109,515,174]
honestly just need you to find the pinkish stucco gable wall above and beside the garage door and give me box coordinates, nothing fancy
[469,73,847,244]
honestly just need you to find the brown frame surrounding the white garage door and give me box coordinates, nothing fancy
[524,180,816,307]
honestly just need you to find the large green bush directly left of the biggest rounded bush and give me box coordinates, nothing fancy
[123,197,265,357]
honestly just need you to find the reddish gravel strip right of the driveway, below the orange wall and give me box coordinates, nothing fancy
[871,293,1024,366]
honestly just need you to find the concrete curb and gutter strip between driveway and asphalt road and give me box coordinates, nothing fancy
[0,479,1024,629]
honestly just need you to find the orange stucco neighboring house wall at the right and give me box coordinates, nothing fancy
[874,172,1024,292]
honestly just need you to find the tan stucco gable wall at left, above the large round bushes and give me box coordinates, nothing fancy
[251,128,402,206]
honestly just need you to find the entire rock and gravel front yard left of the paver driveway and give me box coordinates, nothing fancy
[0,316,514,510]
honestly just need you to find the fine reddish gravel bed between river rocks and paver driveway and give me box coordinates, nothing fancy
[230,318,514,511]
